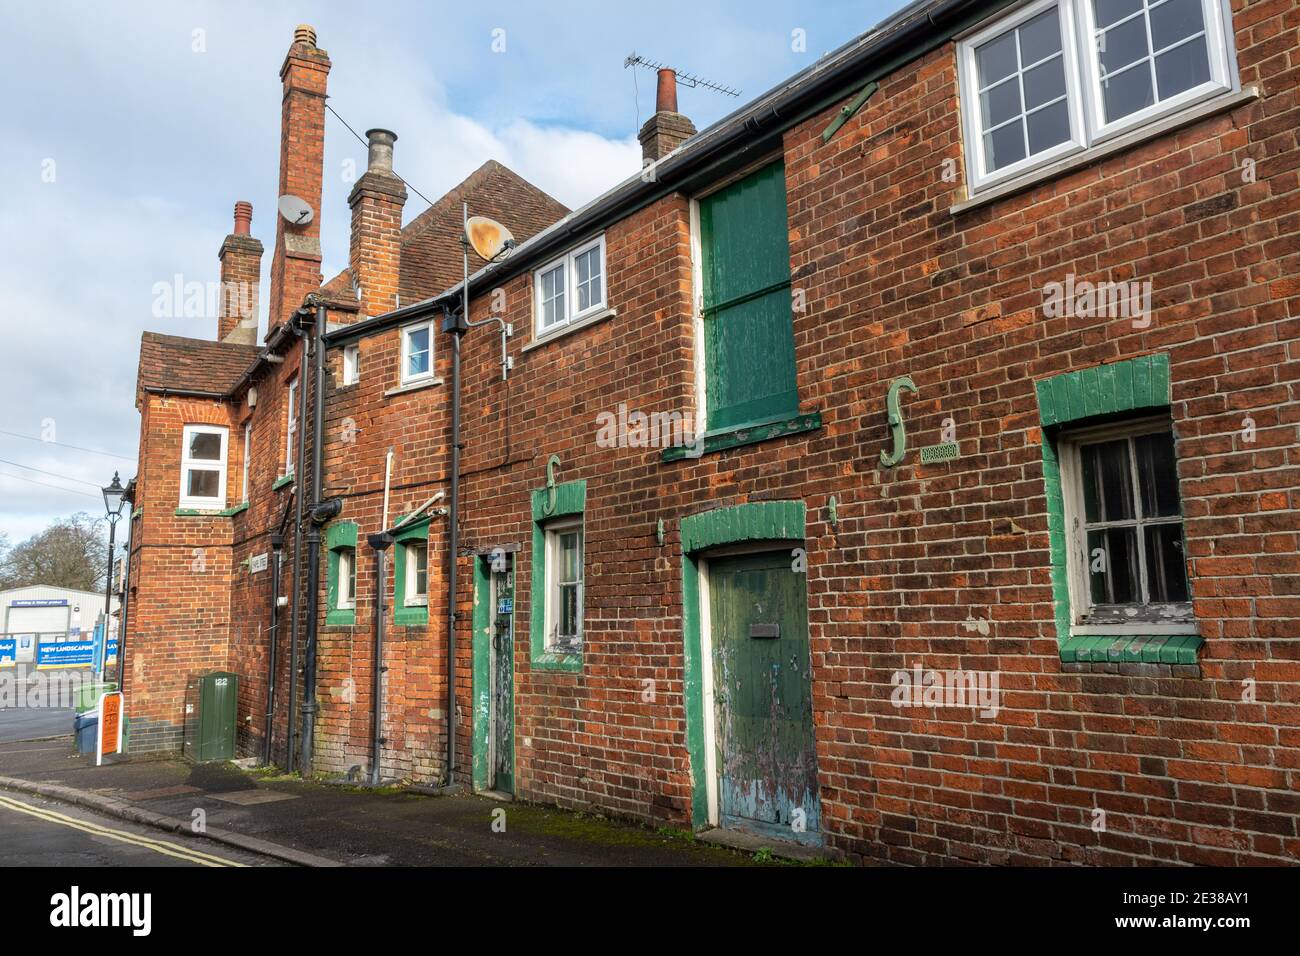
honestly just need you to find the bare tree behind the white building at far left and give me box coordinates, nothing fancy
[0,511,108,591]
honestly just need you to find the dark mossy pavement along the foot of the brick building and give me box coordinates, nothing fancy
[0,736,767,866]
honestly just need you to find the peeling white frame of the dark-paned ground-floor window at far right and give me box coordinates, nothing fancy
[1057,416,1199,636]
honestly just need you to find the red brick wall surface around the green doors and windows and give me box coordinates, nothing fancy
[309,0,1300,864]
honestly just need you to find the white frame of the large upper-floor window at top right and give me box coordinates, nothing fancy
[957,0,1240,195]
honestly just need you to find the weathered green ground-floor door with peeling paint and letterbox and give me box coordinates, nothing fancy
[709,551,822,845]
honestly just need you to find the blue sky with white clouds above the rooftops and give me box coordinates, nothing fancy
[0,0,904,545]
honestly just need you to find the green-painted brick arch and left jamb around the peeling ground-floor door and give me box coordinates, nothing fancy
[681,501,807,830]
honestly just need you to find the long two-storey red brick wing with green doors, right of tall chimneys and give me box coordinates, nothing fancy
[126,0,1300,864]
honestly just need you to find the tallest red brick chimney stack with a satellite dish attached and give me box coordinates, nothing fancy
[267,23,330,336]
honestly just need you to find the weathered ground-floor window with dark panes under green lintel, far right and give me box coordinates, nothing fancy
[1058,420,1195,633]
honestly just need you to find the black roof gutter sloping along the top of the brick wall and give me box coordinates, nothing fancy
[326,0,982,343]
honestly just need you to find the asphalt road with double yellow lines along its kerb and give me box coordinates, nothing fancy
[0,790,282,868]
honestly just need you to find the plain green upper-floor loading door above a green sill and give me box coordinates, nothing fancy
[699,163,800,431]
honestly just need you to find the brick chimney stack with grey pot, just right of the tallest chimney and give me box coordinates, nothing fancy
[347,129,407,319]
